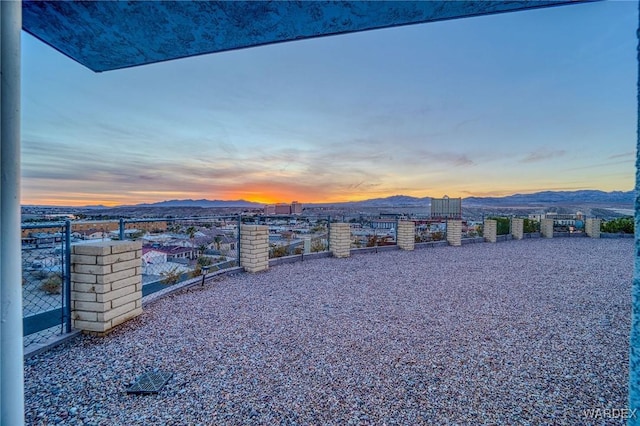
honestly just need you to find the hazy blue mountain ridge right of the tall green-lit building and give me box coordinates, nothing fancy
[462,190,635,206]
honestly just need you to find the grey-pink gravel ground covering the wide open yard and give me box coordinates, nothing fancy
[25,238,634,425]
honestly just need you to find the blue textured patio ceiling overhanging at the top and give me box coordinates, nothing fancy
[22,0,584,71]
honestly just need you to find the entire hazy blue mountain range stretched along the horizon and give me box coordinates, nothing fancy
[131,190,635,208]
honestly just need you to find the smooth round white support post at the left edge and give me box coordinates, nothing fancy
[0,0,24,426]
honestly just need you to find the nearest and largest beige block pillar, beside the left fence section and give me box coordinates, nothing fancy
[71,241,142,335]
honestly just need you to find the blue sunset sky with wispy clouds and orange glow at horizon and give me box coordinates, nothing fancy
[22,1,638,205]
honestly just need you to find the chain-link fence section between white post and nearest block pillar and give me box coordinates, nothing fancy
[22,222,71,346]
